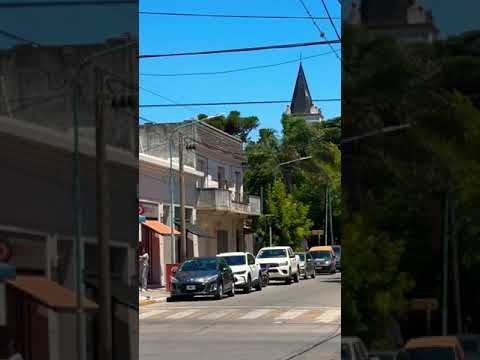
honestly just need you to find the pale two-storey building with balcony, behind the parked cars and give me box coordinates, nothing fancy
[140,123,260,278]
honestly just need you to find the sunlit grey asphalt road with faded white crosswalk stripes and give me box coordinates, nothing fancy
[139,274,341,360]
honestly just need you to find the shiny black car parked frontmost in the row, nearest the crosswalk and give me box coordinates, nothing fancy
[168,257,235,301]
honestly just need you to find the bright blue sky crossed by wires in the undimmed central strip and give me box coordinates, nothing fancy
[140,0,341,136]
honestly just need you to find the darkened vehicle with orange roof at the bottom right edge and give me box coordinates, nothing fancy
[405,336,465,360]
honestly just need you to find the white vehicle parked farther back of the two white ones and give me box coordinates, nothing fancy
[257,246,300,285]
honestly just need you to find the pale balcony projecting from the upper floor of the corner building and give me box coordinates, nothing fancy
[197,188,260,216]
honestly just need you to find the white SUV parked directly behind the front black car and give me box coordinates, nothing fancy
[217,252,262,294]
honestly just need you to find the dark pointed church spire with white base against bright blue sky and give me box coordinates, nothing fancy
[285,63,323,123]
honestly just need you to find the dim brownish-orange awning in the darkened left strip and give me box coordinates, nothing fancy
[7,275,98,312]
